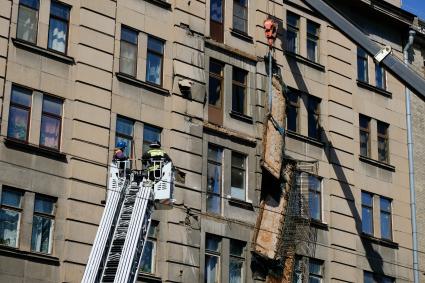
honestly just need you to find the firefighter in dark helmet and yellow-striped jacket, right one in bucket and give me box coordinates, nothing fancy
[142,141,171,181]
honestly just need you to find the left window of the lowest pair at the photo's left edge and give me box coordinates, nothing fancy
[0,187,23,248]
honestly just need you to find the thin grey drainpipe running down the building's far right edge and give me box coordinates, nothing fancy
[403,30,419,283]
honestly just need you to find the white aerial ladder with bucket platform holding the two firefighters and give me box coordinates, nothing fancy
[81,160,174,283]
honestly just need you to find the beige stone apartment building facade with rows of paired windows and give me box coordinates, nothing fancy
[0,0,423,282]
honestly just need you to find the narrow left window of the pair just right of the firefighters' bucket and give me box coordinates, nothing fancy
[207,145,223,214]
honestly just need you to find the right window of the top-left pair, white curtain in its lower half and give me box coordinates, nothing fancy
[47,1,70,53]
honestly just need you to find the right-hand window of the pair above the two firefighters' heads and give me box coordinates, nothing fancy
[146,36,164,85]
